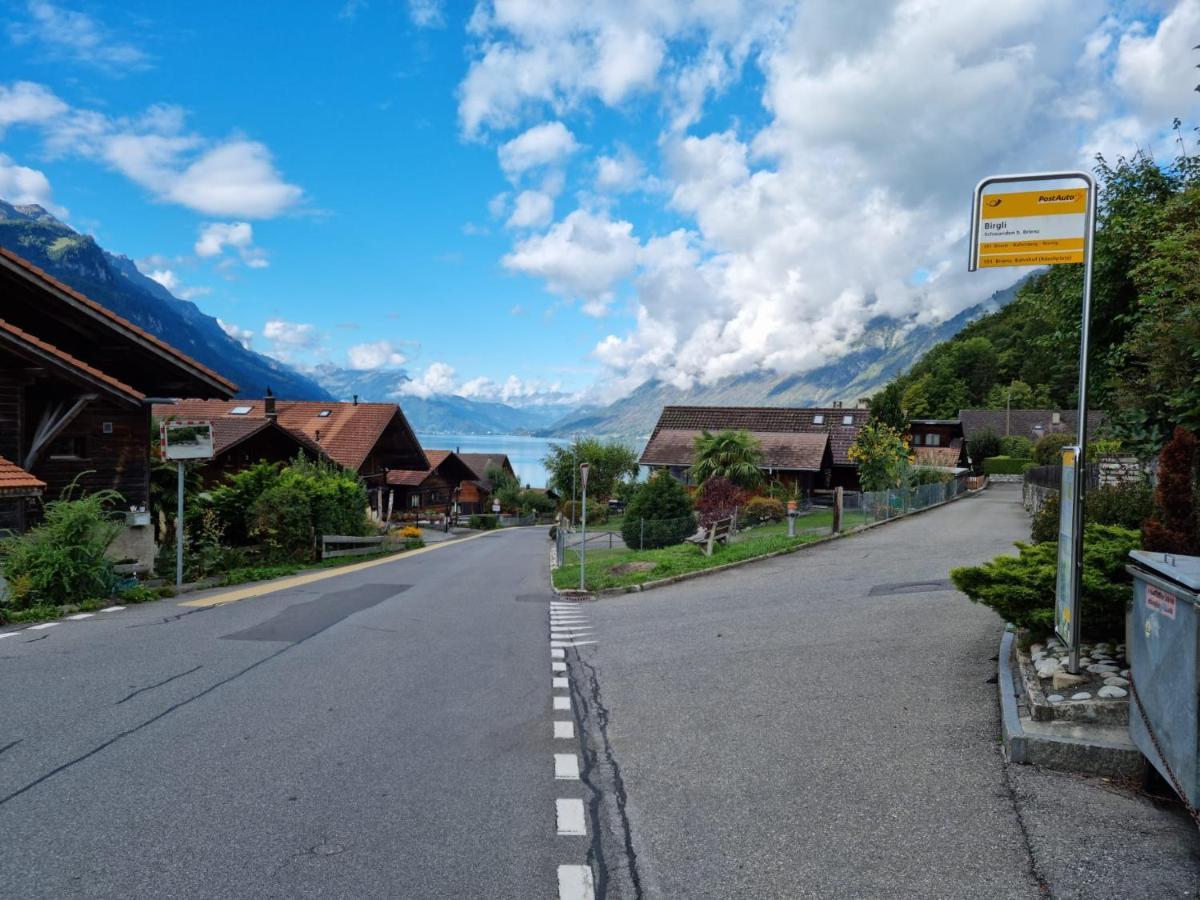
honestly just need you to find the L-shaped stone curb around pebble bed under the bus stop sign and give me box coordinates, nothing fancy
[996,629,1146,778]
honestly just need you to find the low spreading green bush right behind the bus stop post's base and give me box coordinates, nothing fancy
[950,524,1140,637]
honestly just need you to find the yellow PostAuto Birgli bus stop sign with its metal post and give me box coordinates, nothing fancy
[967,172,1097,674]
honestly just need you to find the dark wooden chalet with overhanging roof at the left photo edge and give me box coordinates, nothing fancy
[0,247,238,565]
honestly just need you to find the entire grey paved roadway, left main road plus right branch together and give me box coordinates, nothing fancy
[0,490,1200,900]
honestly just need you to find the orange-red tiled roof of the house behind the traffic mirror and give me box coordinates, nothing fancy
[154,400,419,470]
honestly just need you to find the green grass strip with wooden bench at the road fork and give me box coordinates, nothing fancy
[554,526,822,590]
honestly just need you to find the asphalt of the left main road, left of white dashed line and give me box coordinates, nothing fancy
[0,529,561,899]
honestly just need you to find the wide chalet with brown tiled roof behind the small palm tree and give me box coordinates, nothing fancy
[638,407,870,492]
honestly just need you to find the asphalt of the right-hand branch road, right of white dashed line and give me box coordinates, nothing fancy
[569,487,1200,898]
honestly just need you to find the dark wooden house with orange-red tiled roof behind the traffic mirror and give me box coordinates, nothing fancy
[154,394,430,514]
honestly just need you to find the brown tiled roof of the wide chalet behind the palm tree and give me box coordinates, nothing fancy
[642,407,871,468]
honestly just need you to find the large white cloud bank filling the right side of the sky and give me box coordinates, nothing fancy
[458,0,1200,396]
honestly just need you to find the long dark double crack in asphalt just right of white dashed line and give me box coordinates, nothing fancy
[571,649,644,900]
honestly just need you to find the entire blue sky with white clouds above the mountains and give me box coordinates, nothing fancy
[0,0,1200,404]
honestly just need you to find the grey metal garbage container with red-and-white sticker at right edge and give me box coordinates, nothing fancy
[1126,550,1200,808]
